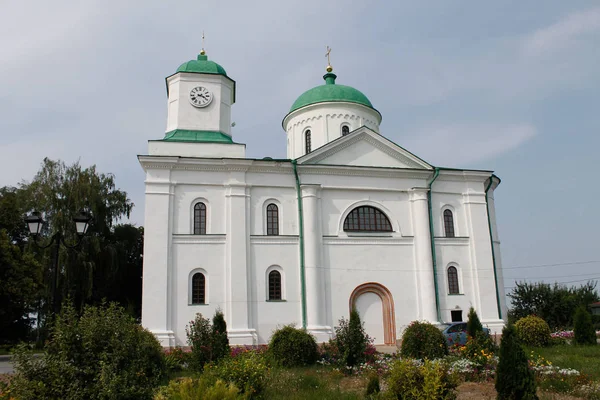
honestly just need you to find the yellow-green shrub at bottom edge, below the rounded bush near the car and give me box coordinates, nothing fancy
[388,359,458,400]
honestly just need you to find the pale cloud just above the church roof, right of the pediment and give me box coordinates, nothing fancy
[405,123,537,167]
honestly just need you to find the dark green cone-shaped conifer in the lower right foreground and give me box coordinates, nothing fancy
[496,324,538,400]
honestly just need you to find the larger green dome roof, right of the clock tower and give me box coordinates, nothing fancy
[290,72,373,112]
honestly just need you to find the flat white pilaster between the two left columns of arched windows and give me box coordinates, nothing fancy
[225,180,256,345]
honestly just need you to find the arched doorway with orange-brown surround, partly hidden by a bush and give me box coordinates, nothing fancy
[350,282,396,345]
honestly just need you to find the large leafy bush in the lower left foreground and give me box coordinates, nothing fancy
[11,302,165,400]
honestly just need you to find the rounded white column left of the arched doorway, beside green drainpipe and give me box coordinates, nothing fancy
[300,185,331,342]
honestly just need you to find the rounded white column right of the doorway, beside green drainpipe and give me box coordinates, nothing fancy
[409,188,438,323]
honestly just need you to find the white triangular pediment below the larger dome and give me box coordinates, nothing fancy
[298,127,432,169]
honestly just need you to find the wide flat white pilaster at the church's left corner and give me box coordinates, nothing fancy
[142,170,175,347]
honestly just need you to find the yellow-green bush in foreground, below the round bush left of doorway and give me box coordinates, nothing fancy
[204,351,269,396]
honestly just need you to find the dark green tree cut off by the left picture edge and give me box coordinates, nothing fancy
[0,229,43,343]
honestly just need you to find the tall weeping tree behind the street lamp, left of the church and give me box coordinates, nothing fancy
[20,158,135,330]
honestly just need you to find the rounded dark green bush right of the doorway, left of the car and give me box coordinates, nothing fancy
[400,321,448,360]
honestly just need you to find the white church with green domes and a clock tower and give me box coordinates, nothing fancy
[138,50,506,347]
